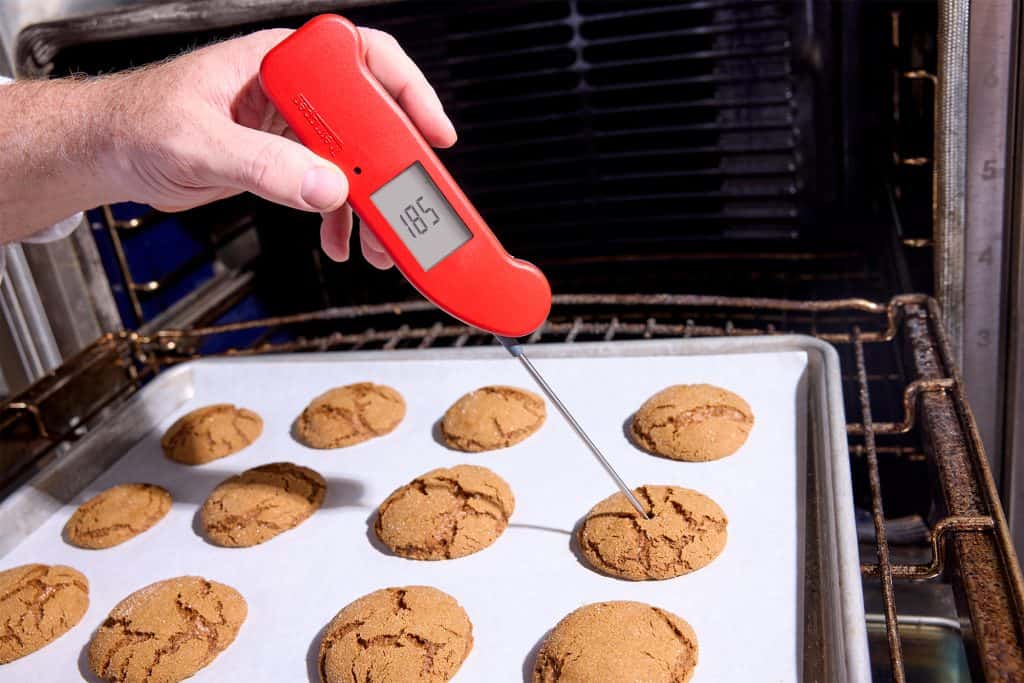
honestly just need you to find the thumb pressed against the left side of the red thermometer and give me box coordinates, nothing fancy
[210,123,348,212]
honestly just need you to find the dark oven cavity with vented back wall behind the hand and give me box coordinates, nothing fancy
[18,0,936,329]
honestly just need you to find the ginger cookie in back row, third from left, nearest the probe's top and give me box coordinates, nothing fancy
[441,386,547,452]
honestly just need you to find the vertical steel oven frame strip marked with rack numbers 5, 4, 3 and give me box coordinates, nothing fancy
[962,0,1015,475]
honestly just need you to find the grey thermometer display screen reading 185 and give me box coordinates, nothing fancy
[370,162,473,270]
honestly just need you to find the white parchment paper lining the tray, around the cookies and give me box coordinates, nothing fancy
[0,345,862,683]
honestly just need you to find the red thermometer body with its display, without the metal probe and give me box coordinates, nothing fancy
[260,14,551,337]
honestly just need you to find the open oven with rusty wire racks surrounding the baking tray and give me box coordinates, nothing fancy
[0,0,1024,681]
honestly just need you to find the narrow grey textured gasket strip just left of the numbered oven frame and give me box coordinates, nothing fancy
[932,0,972,360]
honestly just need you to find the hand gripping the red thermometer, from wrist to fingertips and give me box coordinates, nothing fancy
[112,29,456,268]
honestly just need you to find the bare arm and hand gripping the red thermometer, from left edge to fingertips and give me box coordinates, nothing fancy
[0,29,456,267]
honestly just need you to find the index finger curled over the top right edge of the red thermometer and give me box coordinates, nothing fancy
[359,28,457,147]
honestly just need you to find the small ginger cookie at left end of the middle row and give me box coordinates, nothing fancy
[65,483,171,549]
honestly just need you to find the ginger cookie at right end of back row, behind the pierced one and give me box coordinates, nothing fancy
[630,384,754,462]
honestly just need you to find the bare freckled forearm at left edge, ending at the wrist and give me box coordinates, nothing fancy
[0,77,124,244]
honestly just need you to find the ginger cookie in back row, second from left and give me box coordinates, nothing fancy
[295,382,406,449]
